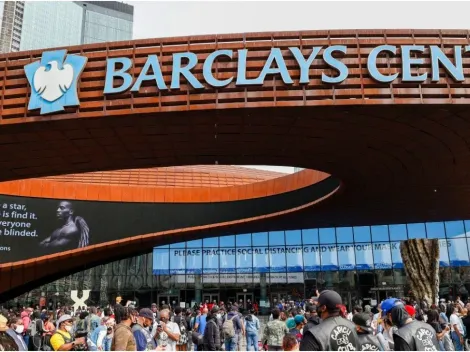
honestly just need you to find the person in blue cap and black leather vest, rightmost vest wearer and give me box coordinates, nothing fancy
[382,298,440,351]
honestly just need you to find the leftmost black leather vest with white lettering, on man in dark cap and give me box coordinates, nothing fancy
[308,316,360,351]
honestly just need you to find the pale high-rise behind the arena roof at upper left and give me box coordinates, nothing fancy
[0,1,134,52]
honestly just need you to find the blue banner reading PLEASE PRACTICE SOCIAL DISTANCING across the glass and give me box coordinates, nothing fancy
[153,238,464,275]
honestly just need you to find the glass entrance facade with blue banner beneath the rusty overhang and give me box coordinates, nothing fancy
[9,220,470,310]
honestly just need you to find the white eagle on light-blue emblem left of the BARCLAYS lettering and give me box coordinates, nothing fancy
[24,50,88,115]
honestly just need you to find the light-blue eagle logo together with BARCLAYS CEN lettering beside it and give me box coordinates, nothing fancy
[24,45,470,114]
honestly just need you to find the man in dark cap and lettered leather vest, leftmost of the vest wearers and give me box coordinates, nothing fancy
[300,290,360,351]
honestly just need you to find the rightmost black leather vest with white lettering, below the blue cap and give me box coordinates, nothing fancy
[394,320,440,351]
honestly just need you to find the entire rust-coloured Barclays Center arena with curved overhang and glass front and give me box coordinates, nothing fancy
[0,30,470,311]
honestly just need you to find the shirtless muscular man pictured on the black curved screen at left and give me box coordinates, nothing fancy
[40,201,90,249]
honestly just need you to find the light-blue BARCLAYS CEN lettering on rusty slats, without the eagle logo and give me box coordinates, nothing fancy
[104,45,470,94]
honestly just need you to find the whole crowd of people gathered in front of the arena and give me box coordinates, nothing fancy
[0,290,470,351]
